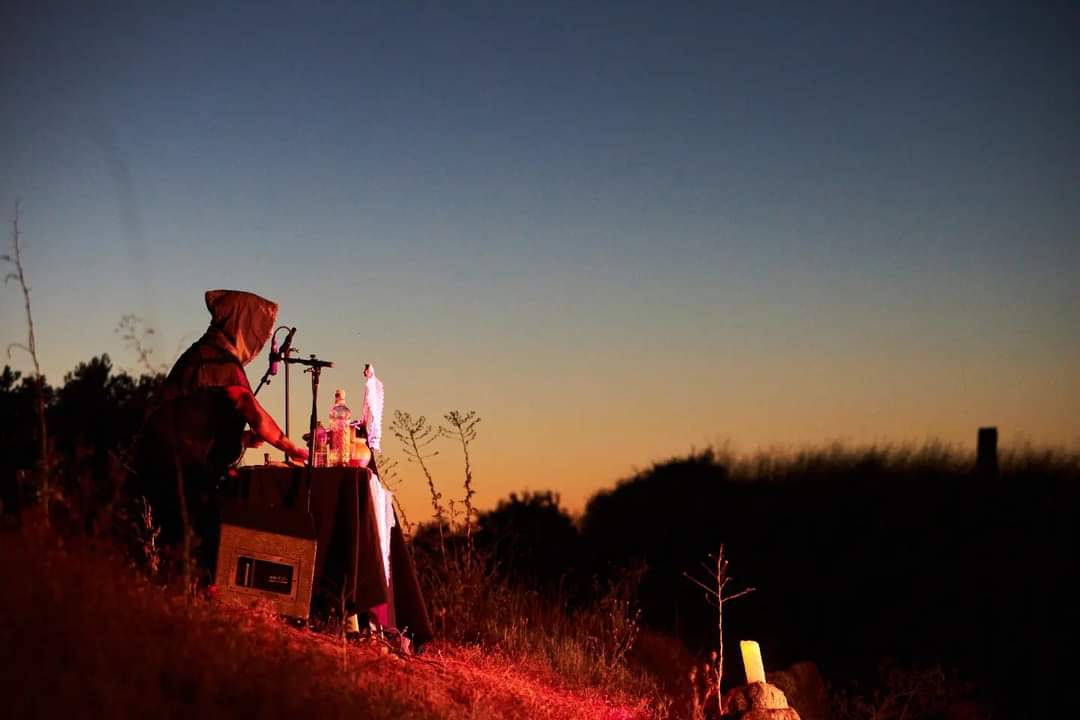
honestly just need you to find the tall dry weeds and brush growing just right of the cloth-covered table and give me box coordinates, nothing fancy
[391,411,670,715]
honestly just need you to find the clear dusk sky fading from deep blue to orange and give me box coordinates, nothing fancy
[0,0,1080,517]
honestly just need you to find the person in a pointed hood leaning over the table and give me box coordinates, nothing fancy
[134,290,308,567]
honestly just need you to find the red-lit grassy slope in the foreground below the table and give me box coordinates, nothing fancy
[0,524,650,719]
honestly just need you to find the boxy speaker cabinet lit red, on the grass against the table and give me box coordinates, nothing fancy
[215,503,315,620]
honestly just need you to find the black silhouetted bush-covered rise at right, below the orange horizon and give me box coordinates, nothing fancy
[582,445,1080,716]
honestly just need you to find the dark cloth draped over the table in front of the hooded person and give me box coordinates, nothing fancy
[237,465,432,643]
